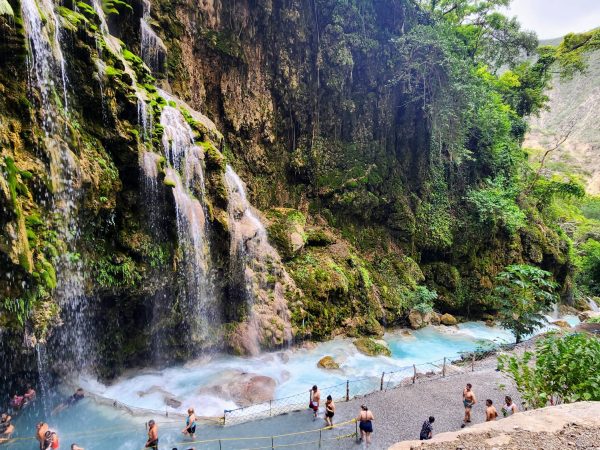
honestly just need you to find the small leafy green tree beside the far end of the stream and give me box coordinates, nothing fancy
[494,264,556,343]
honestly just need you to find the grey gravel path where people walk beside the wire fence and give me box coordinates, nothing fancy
[325,364,521,449]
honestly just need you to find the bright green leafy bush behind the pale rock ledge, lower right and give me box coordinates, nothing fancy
[498,332,600,408]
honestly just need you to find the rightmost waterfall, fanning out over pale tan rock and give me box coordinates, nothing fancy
[225,165,291,355]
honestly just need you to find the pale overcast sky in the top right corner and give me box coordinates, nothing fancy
[510,0,600,39]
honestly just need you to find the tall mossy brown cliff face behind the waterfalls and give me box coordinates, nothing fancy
[0,0,570,384]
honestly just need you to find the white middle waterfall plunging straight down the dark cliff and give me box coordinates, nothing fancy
[141,106,221,352]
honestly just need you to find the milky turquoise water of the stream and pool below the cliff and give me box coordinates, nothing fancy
[3,317,578,450]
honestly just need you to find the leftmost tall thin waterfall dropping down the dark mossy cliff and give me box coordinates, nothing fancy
[21,0,91,376]
